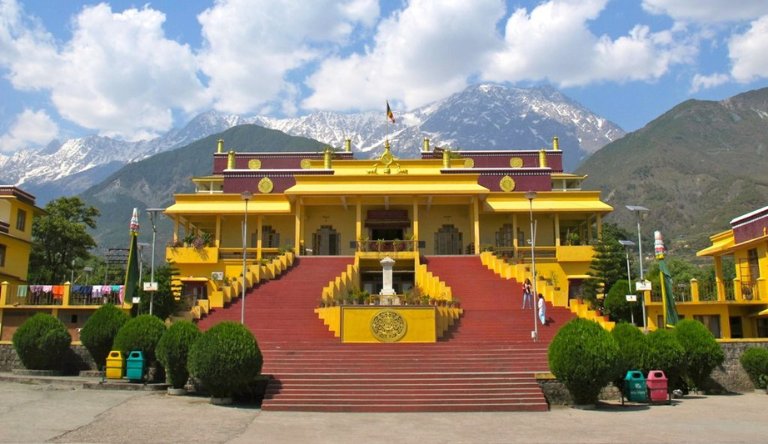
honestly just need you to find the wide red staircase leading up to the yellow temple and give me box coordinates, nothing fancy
[199,256,573,412]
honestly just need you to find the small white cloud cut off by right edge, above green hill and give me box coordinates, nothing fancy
[728,15,768,83]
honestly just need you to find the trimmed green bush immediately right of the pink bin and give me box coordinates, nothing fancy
[673,319,725,388]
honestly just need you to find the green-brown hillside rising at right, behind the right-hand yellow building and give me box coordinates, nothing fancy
[577,88,768,256]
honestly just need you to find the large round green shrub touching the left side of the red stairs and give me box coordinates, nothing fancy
[188,322,264,398]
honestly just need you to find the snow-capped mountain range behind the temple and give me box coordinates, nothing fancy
[0,84,624,204]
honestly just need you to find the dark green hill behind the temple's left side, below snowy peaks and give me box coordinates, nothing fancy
[81,125,325,251]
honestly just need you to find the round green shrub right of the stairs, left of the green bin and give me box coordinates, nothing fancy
[548,318,619,404]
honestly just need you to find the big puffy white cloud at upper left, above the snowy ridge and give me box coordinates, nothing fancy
[2,3,208,140]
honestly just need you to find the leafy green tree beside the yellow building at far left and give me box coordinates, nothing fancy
[29,197,99,284]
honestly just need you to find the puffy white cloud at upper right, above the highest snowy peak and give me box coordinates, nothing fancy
[483,0,696,87]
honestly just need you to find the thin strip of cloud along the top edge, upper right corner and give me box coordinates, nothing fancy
[643,0,768,23]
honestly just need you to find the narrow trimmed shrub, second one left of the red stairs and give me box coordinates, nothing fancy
[155,321,202,388]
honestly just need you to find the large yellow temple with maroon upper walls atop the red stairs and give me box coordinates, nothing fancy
[165,138,612,338]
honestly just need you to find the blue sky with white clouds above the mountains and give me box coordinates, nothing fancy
[0,0,768,155]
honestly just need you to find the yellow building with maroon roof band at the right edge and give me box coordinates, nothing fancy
[664,207,768,339]
